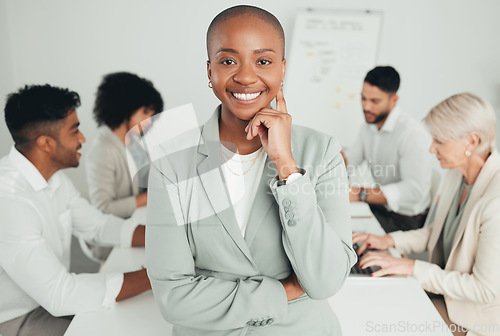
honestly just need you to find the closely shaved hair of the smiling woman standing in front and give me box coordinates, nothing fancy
[207,5,285,57]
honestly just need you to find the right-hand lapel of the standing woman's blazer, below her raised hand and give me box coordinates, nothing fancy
[245,157,278,246]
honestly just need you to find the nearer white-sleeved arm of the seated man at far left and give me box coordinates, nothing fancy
[0,199,149,316]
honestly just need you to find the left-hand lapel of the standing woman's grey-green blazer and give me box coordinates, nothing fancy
[197,108,253,264]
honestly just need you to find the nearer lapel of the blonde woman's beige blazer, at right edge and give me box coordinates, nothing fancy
[448,152,499,260]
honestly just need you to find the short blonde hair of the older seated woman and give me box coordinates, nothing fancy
[424,92,497,155]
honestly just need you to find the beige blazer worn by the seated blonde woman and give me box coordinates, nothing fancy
[391,152,500,335]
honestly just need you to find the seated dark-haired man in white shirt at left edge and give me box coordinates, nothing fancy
[0,85,151,336]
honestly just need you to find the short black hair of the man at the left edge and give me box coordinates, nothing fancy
[4,84,80,149]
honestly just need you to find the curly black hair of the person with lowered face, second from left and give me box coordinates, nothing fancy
[94,72,163,129]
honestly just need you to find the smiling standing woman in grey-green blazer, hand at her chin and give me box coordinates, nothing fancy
[146,6,356,335]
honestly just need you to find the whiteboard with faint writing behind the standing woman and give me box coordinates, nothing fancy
[283,10,382,147]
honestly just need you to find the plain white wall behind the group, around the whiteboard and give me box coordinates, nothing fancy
[0,0,500,195]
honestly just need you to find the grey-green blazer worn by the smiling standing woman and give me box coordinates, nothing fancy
[146,109,356,336]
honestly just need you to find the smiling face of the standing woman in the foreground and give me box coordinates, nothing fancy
[207,9,286,127]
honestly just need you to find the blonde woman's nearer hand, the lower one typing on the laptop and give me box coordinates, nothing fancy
[359,251,415,277]
